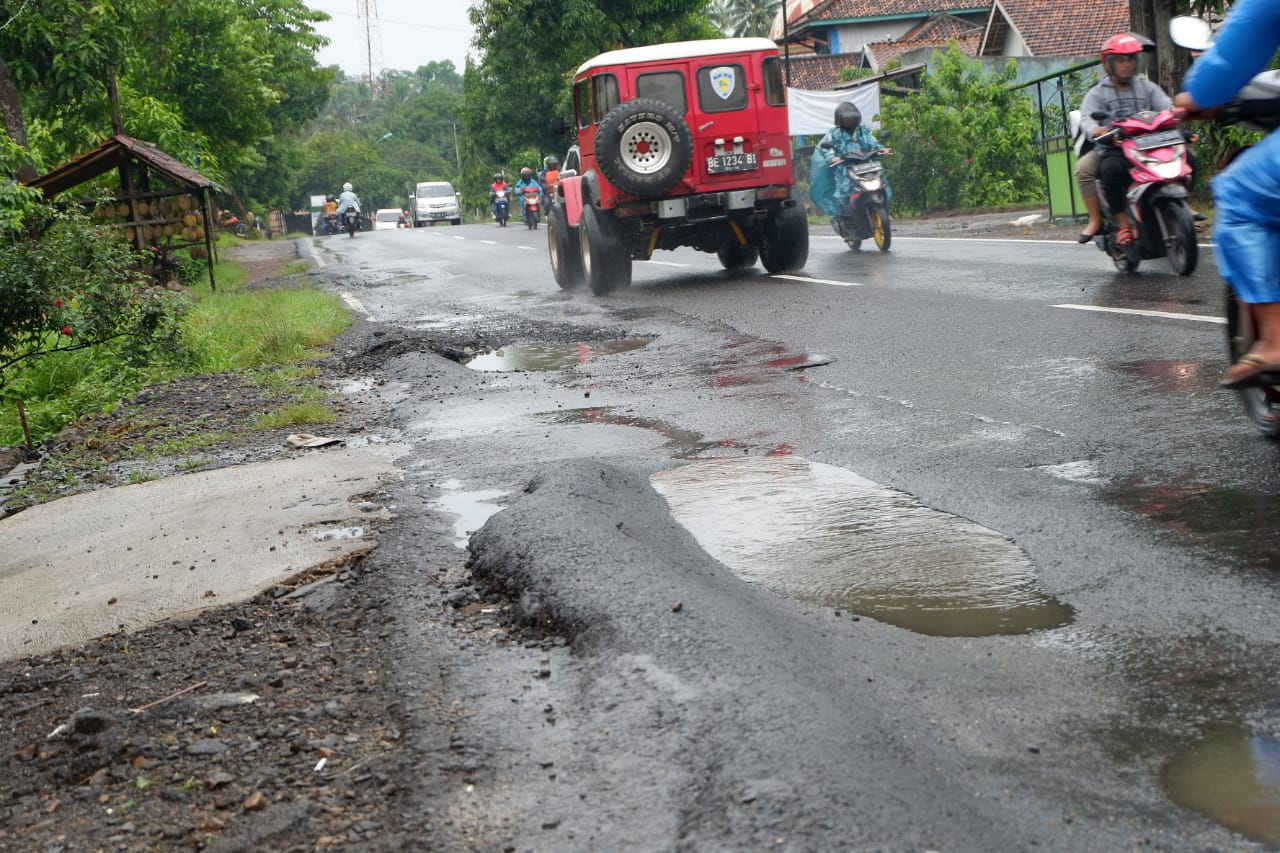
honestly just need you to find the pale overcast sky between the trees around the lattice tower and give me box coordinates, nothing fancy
[305,0,475,77]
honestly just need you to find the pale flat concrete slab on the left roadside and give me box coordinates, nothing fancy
[0,446,403,660]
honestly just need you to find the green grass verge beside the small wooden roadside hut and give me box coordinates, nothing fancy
[0,240,352,446]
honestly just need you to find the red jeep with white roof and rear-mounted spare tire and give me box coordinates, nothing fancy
[547,38,809,296]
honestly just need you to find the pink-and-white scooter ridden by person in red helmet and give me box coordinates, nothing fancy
[1093,110,1199,275]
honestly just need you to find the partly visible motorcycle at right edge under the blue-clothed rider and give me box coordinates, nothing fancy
[1169,15,1280,438]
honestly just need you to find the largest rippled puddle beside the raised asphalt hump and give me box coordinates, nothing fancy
[653,455,1075,637]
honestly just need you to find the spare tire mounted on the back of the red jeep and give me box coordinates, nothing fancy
[595,97,694,197]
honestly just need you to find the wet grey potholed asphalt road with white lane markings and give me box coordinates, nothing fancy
[307,225,1280,850]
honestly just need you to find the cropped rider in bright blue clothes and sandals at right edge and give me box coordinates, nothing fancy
[1174,0,1280,388]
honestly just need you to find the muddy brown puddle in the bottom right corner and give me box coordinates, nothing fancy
[1161,725,1280,845]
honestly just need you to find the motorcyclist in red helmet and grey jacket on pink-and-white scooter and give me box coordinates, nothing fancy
[1075,32,1172,247]
